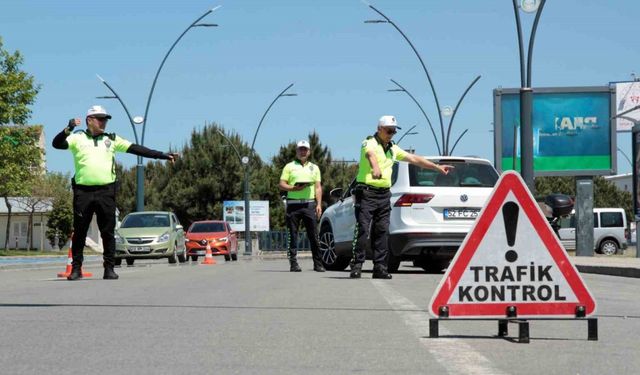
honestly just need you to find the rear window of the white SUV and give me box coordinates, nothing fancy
[409,160,499,187]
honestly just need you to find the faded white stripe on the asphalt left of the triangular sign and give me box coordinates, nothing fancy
[371,280,505,375]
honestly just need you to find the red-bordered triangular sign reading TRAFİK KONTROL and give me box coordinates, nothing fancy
[429,171,596,318]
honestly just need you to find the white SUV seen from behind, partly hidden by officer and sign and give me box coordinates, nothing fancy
[320,156,499,272]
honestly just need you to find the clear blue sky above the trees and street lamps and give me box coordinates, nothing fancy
[0,0,640,176]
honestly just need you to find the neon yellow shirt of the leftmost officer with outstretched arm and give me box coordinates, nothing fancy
[67,131,131,186]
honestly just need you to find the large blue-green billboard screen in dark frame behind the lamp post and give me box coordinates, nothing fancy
[494,86,616,176]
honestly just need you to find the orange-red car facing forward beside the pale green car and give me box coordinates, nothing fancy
[185,220,238,262]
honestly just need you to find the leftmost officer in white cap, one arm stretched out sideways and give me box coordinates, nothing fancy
[53,105,178,280]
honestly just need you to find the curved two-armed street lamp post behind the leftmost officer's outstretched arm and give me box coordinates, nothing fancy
[97,5,221,211]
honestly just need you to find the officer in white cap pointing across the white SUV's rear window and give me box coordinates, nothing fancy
[349,116,453,279]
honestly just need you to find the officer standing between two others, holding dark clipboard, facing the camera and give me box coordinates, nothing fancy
[279,140,325,272]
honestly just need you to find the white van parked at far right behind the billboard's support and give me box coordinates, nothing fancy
[558,208,629,255]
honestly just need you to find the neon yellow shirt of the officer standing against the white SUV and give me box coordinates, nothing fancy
[356,136,407,188]
